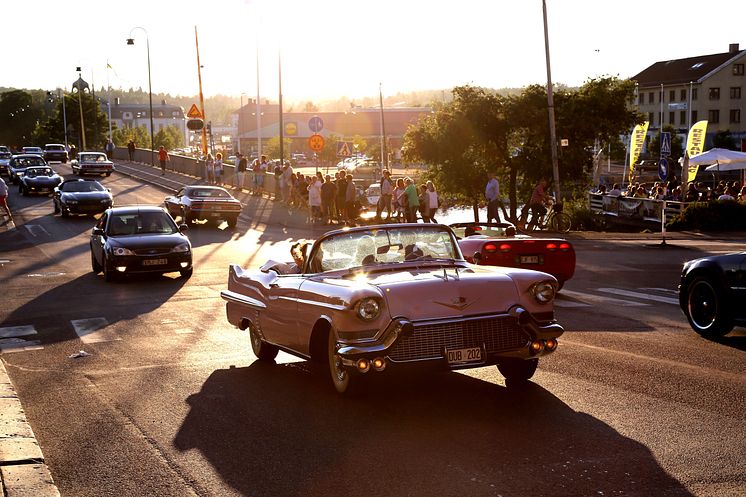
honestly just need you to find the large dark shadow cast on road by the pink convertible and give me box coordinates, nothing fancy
[174,362,691,497]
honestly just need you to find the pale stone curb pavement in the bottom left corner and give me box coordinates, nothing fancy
[0,360,60,497]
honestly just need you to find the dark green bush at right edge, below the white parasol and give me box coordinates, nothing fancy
[667,201,746,231]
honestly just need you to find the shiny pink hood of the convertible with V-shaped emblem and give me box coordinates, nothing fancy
[326,265,528,320]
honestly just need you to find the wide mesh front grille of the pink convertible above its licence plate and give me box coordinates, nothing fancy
[389,316,528,361]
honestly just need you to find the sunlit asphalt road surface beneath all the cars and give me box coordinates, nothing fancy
[0,166,746,497]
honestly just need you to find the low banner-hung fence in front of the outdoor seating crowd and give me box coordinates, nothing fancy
[588,193,687,223]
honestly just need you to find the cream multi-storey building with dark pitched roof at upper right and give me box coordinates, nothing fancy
[631,43,746,150]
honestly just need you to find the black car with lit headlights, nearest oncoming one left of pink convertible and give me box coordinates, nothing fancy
[91,206,192,281]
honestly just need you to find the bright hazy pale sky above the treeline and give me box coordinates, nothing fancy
[0,0,746,102]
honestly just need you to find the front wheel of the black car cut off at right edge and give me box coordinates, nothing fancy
[686,276,734,338]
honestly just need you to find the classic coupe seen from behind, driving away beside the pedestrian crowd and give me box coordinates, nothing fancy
[164,186,241,227]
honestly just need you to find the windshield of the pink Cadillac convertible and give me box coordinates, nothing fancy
[309,226,461,273]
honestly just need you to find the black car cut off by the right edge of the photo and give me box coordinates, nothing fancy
[679,252,746,338]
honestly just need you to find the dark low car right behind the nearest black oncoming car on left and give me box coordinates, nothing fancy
[52,178,114,217]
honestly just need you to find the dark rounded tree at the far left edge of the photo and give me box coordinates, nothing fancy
[0,90,44,148]
